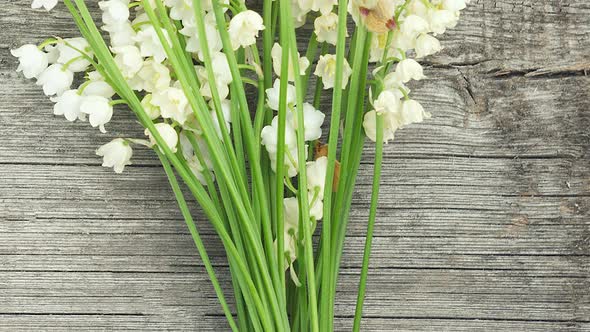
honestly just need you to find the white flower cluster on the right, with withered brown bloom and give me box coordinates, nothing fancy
[360,0,469,142]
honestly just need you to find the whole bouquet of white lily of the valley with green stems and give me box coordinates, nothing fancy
[12,0,468,331]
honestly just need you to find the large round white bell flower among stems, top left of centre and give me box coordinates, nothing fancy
[228,10,264,50]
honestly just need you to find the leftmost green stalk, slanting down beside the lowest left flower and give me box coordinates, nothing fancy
[154,148,238,331]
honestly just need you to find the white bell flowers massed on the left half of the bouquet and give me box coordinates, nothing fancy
[11,0,264,183]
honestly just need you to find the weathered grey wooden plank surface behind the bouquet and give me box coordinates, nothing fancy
[0,0,590,331]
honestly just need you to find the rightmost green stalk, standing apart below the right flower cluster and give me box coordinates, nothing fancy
[352,115,383,332]
